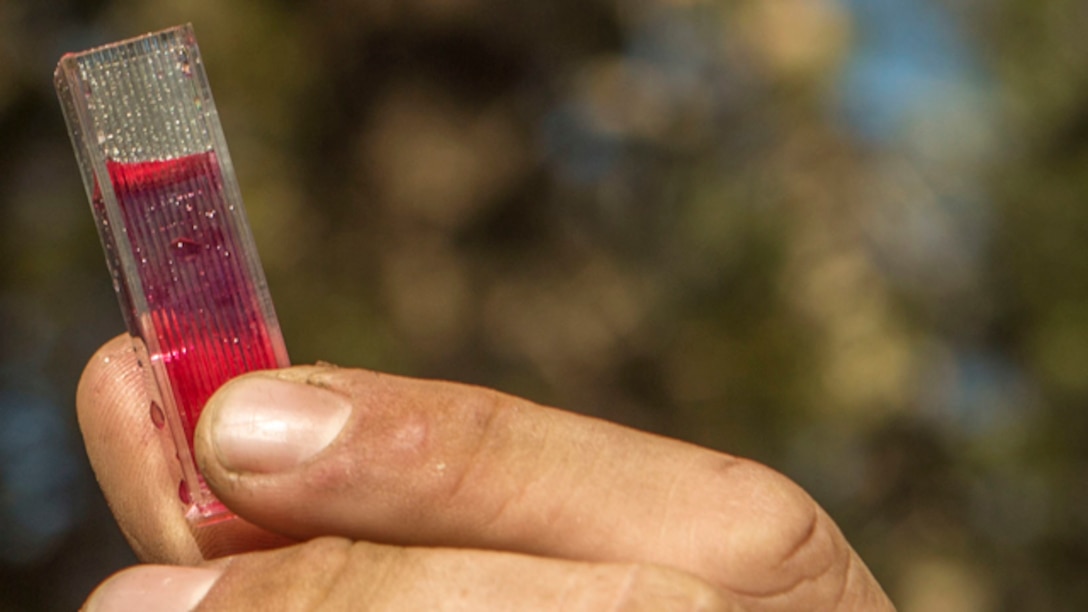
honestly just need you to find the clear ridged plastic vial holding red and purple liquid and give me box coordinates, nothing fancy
[54,25,288,526]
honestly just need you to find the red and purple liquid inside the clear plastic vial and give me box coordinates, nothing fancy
[107,152,286,511]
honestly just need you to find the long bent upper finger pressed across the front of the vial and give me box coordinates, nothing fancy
[196,367,889,610]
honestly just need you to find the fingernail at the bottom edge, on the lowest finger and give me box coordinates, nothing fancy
[84,565,221,612]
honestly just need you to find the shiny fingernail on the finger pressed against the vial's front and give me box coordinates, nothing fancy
[208,375,351,474]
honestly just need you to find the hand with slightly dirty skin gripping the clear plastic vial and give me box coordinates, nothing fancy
[77,336,893,611]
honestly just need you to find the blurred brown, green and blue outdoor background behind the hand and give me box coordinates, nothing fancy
[0,0,1088,612]
